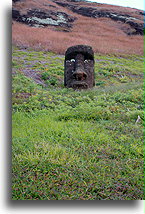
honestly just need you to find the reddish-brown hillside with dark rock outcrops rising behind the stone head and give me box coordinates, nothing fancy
[12,0,143,55]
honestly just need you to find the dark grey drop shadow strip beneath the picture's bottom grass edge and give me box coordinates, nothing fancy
[7,200,139,211]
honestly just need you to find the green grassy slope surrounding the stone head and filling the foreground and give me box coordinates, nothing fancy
[12,48,143,200]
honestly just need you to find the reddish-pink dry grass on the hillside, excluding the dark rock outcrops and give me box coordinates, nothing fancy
[12,0,143,55]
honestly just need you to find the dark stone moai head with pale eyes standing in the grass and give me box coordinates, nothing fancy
[64,45,95,89]
